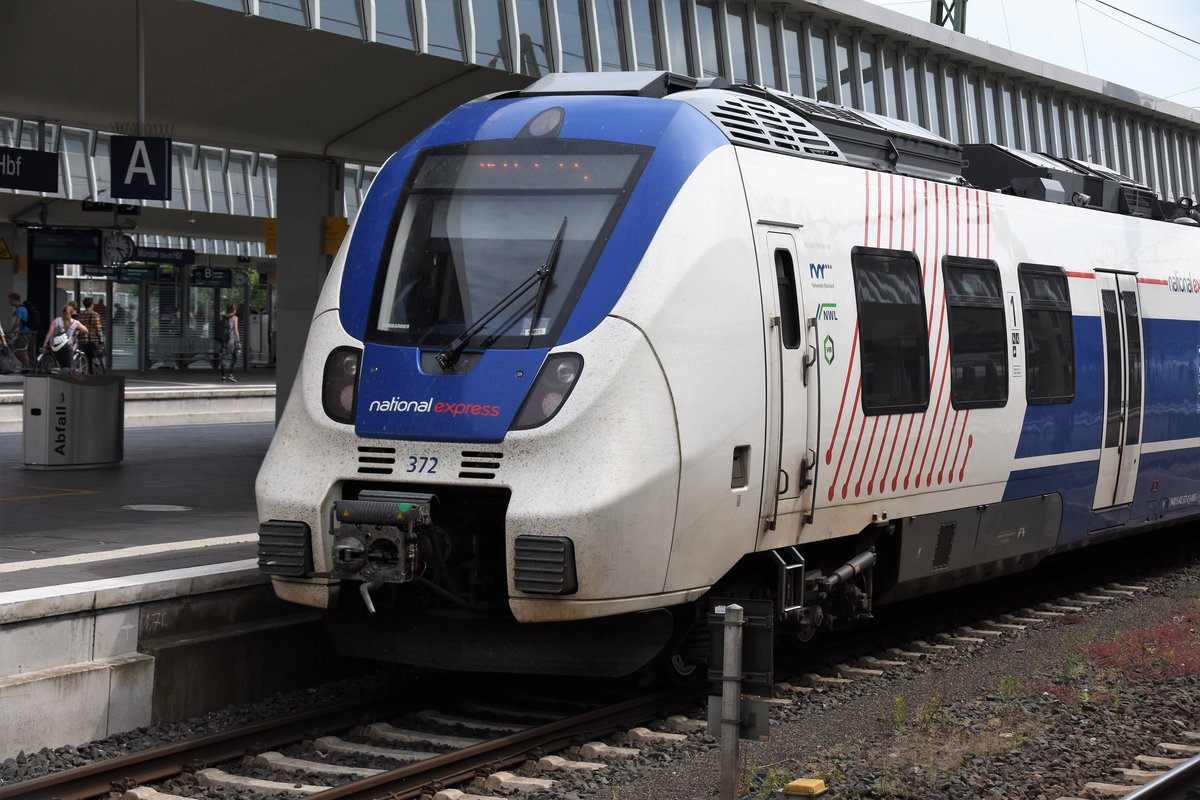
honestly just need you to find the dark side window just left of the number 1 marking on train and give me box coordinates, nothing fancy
[942,255,1008,409]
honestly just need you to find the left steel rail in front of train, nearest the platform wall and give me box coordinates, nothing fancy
[0,693,412,800]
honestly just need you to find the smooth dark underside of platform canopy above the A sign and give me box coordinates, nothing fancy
[0,0,532,163]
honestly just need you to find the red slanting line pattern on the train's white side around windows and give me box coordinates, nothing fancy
[824,172,993,501]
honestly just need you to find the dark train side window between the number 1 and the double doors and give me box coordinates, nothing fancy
[1018,264,1075,404]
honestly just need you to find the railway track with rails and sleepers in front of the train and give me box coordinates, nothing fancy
[0,687,704,800]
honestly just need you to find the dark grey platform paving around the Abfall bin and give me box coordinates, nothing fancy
[0,412,275,594]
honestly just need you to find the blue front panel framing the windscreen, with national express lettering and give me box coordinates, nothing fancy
[340,97,730,443]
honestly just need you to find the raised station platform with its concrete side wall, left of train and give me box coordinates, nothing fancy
[0,383,348,759]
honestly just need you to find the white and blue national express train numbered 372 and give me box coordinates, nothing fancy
[256,72,1200,676]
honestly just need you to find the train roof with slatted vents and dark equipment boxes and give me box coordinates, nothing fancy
[493,72,1200,225]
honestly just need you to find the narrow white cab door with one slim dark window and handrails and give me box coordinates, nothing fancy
[763,231,816,529]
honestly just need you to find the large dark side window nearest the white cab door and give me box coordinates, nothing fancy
[851,247,929,416]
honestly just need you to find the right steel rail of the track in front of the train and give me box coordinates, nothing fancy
[310,686,707,800]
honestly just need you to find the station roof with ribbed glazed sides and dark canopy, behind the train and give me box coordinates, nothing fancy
[0,0,1200,247]
